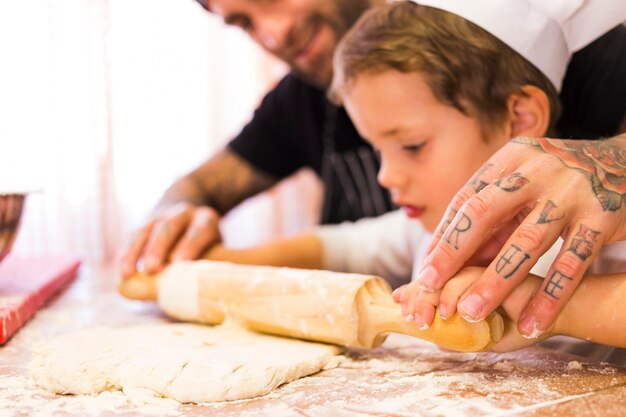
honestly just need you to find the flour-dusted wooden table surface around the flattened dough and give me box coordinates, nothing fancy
[0,266,626,417]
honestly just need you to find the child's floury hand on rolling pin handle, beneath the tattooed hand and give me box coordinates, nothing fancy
[393,267,552,352]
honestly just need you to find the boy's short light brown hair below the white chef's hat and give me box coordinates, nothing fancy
[329,1,560,131]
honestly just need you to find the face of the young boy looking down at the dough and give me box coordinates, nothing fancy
[343,70,510,232]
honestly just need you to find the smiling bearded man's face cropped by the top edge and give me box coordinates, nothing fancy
[198,0,373,88]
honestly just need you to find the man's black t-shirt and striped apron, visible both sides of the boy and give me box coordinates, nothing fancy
[229,26,626,223]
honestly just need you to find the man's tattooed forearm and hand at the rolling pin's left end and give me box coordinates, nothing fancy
[120,149,278,278]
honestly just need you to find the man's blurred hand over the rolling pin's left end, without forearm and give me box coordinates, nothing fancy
[120,202,221,278]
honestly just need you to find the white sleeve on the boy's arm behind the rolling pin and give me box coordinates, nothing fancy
[313,210,428,288]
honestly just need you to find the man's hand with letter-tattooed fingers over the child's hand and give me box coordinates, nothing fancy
[412,135,626,338]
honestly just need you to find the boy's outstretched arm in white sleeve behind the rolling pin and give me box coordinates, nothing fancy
[203,211,420,287]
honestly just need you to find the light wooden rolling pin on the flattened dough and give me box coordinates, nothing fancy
[119,261,504,352]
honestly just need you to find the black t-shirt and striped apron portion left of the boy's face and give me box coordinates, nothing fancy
[229,75,393,223]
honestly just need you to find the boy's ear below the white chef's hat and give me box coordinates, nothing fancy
[508,85,550,137]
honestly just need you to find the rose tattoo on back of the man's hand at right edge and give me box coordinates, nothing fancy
[512,135,626,211]
